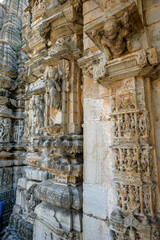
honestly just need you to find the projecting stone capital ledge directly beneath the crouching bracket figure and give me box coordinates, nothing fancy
[78,48,158,86]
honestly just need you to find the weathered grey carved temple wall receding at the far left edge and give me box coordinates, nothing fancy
[0,0,27,228]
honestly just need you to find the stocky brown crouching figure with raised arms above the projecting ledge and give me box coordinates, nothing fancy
[92,13,131,60]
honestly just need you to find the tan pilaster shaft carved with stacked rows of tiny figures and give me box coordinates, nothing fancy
[110,78,159,240]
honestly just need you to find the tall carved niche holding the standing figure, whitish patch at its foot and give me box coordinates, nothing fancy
[44,60,70,135]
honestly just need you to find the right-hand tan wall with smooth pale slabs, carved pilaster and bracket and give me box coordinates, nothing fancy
[78,0,160,240]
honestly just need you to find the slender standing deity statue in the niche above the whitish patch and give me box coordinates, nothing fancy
[44,66,62,125]
